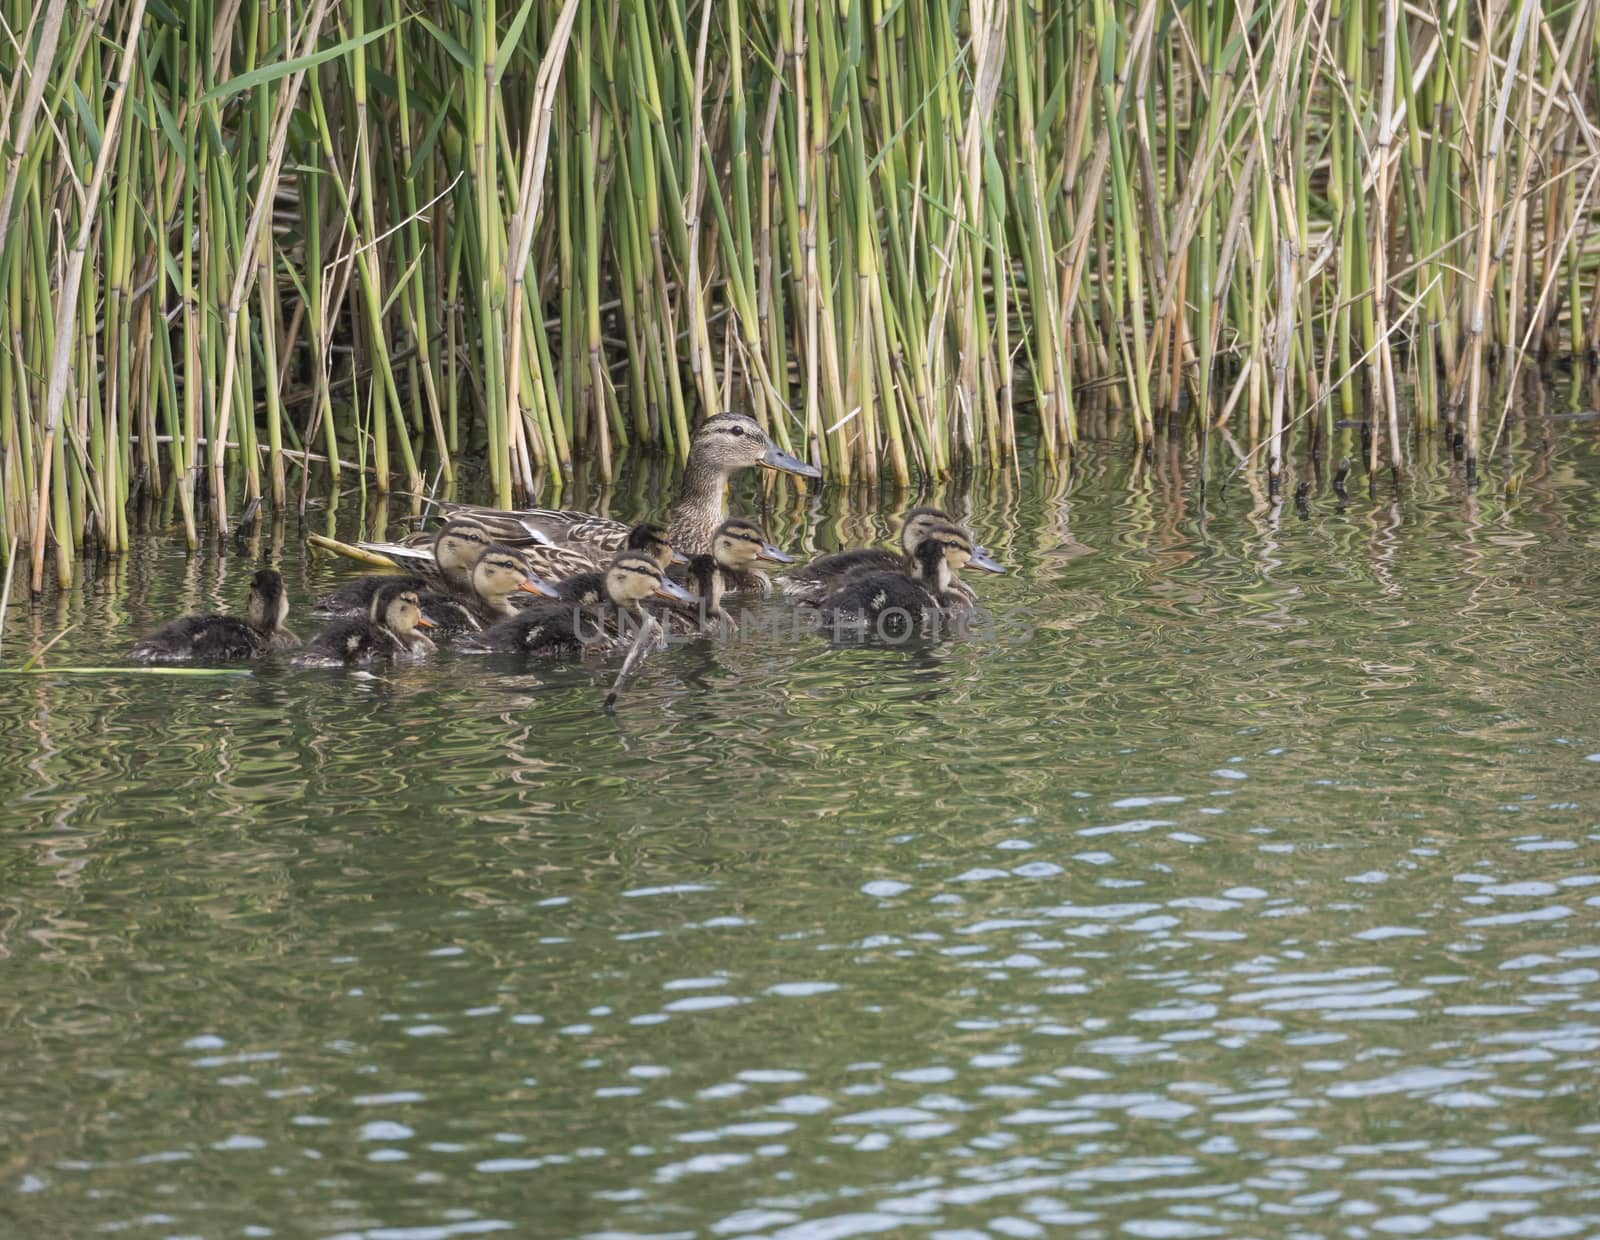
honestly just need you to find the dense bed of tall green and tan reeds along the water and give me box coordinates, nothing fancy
[0,0,1600,590]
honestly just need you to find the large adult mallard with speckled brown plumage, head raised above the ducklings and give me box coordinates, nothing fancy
[446,413,822,560]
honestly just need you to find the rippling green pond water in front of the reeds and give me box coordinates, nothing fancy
[0,421,1600,1240]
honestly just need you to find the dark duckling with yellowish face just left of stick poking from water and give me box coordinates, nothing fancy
[461,552,694,654]
